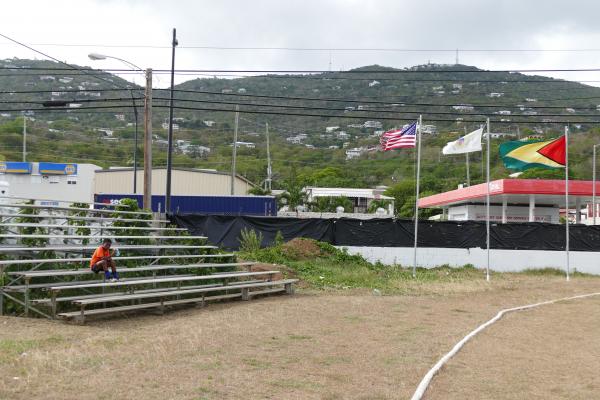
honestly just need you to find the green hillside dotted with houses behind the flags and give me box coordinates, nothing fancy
[0,59,600,212]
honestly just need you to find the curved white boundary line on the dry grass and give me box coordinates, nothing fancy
[411,292,600,400]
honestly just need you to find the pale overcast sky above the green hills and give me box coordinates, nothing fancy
[0,0,600,87]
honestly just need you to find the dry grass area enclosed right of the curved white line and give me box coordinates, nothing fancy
[425,296,600,400]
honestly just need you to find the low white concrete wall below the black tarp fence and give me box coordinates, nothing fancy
[337,246,600,275]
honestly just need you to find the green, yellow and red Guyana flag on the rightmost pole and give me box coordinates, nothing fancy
[500,136,566,171]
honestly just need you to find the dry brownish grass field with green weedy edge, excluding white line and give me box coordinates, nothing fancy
[0,239,600,400]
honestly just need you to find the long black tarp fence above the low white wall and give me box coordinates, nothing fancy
[169,214,600,251]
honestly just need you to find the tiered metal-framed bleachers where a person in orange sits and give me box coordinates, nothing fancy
[0,197,297,323]
